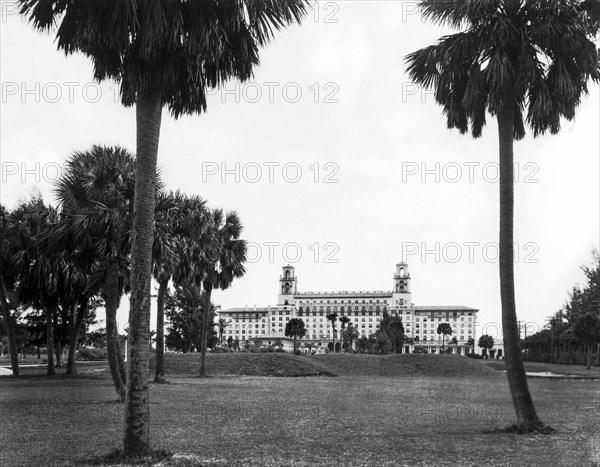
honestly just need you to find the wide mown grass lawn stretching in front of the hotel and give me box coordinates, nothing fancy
[0,355,600,466]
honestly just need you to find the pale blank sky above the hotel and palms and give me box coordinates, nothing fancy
[0,0,600,337]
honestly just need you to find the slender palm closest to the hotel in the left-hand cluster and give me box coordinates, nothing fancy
[196,209,247,377]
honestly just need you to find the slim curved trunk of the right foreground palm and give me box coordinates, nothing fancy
[498,98,542,431]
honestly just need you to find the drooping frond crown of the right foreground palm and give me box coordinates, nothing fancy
[407,0,600,139]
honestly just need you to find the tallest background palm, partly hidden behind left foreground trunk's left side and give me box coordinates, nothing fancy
[55,145,135,401]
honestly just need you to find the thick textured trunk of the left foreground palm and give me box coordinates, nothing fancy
[123,80,162,456]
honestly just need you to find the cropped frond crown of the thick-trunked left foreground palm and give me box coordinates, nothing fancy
[19,0,307,118]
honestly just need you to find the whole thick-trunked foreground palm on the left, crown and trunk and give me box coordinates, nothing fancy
[19,0,308,455]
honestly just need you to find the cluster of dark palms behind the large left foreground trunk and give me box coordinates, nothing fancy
[0,146,246,394]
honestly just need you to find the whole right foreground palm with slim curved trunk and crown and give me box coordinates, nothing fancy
[407,0,600,431]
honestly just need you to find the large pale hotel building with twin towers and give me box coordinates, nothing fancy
[217,263,478,354]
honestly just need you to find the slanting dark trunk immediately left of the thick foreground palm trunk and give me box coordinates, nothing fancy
[102,263,125,401]
